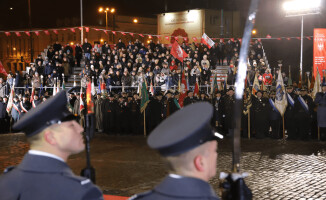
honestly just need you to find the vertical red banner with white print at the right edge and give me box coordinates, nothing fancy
[313,28,326,77]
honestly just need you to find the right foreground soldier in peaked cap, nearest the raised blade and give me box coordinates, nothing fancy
[130,102,219,200]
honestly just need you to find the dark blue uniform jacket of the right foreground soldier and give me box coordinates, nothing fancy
[129,176,219,200]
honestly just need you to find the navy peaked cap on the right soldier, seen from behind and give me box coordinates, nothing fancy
[147,102,222,156]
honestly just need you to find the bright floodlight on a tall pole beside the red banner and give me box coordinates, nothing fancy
[283,0,322,77]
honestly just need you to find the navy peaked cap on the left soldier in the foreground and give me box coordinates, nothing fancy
[13,91,73,137]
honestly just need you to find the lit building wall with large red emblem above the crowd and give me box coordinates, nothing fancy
[157,9,244,43]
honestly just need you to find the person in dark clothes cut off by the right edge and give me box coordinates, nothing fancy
[315,83,326,140]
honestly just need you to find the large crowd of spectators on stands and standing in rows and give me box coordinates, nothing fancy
[0,39,326,139]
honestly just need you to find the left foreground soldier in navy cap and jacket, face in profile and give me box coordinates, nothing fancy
[0,91,103,200]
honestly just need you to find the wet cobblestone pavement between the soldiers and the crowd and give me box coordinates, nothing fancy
[0,134,326,200]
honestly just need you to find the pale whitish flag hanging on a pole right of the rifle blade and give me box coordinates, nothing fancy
[275,70,288,116]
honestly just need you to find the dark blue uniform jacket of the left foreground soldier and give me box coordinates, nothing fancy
[0,154,103,200]
